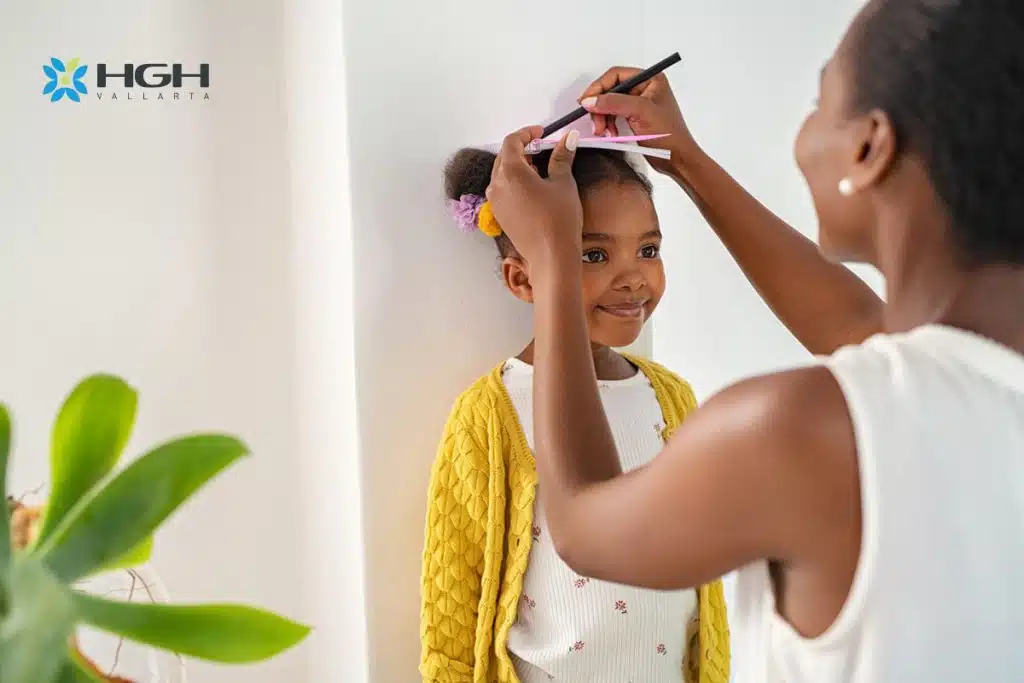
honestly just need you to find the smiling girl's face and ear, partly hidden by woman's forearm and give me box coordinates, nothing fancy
[503,183,665,347]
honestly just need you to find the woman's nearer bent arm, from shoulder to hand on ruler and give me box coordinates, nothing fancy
[487,127,860,630]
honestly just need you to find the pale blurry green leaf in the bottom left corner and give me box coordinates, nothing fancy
[0,556,75,683]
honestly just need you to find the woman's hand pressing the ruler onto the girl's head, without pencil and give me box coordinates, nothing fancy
[487,126,583,274]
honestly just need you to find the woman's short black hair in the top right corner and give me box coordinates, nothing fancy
[849,0,1024,266]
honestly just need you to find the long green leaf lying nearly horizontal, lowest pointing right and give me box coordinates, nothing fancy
[74,593,309,664]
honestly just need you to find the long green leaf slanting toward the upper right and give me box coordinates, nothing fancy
[36,434,248,583]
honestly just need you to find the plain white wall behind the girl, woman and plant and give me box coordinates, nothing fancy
[0,0,880,683]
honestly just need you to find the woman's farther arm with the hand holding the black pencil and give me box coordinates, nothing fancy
[583,68,883,354]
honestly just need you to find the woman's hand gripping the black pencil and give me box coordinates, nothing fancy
[580,67,698,179]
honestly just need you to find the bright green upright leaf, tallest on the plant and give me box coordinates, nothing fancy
[36,375,138,545]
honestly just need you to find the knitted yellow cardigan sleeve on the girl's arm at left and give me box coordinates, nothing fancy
[420,395,488,683]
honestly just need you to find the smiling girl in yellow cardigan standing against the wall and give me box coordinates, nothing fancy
[420,150,729,683]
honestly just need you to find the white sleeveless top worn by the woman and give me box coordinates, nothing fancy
[732,325,1024,683]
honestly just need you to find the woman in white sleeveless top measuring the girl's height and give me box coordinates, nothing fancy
[487,0,1024,683]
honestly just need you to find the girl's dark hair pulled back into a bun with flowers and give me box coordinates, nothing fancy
[444,148,651,258]
